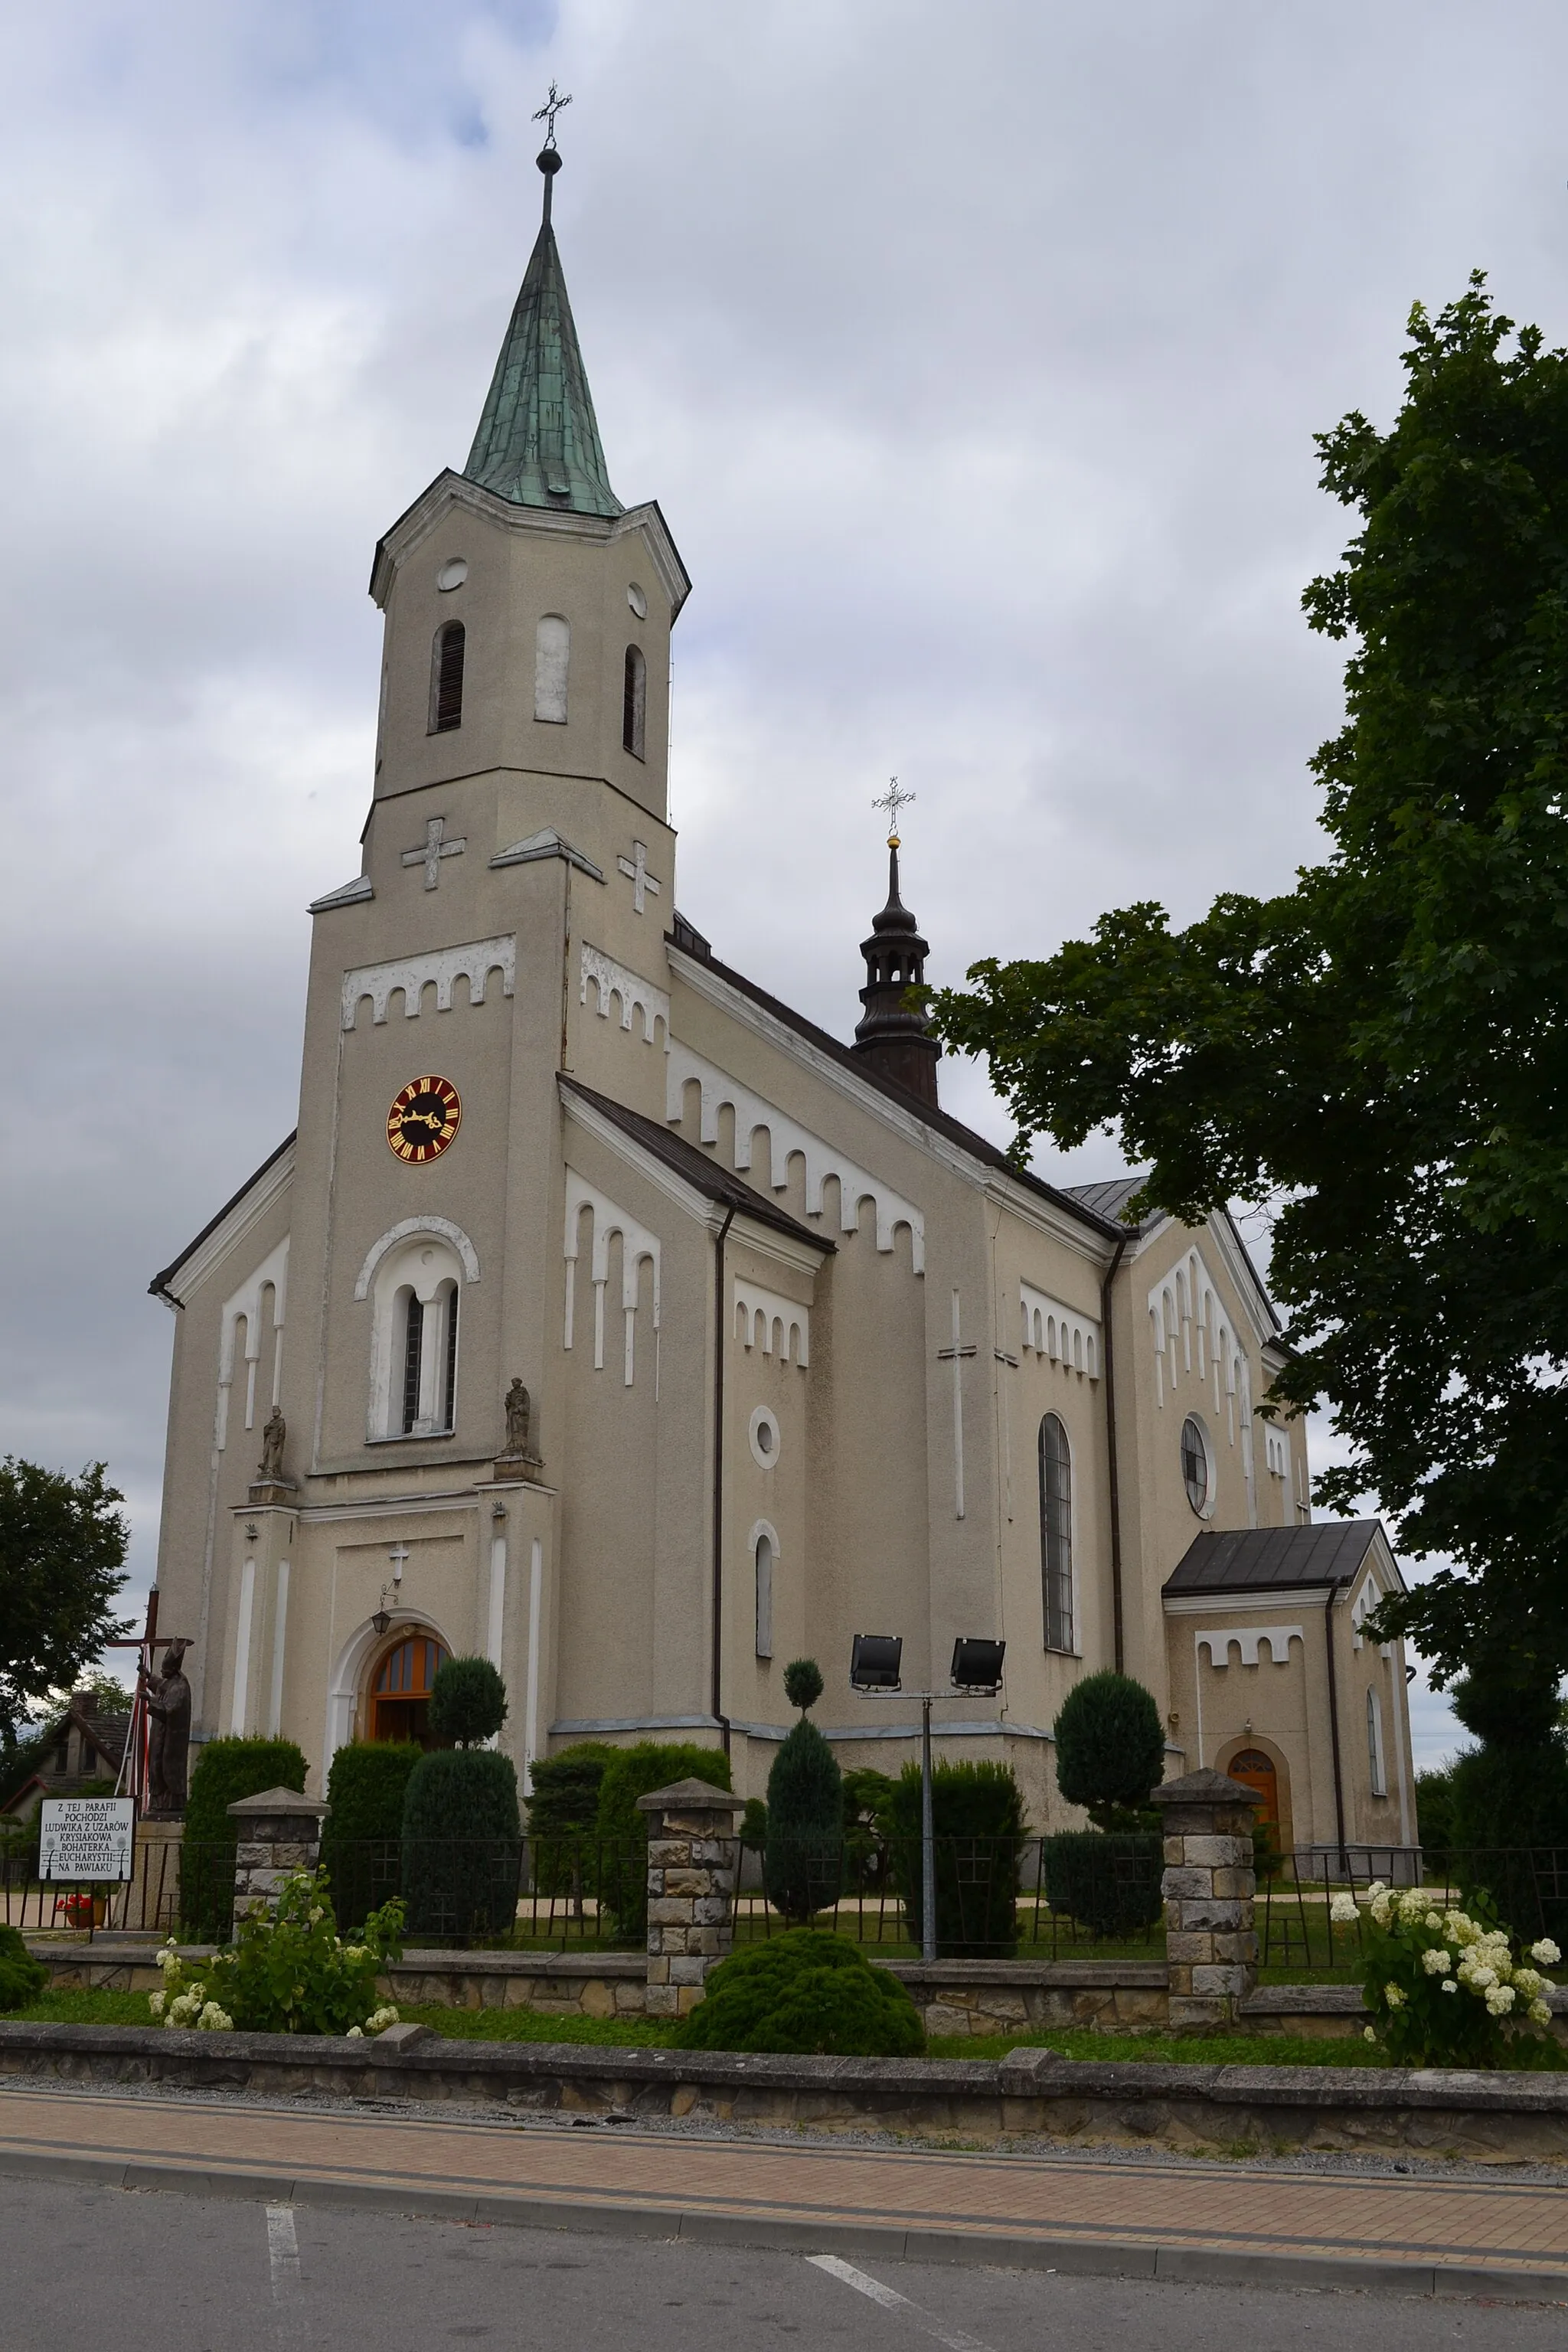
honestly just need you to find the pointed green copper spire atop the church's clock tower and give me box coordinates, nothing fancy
[463,126,626,518]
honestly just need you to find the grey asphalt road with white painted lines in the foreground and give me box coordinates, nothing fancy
[0,2178,1563,2352]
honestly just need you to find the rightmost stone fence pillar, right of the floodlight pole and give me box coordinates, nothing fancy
[1149,1769,1258,2032]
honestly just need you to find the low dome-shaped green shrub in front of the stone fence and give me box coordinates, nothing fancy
[675,1929,926,2058]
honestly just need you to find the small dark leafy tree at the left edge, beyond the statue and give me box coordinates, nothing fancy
[0,1453,132,1750]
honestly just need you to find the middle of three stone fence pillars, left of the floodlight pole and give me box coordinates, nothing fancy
[637,1781,745,2018]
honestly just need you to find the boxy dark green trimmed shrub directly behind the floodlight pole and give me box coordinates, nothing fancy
[884,1764,1025,1959]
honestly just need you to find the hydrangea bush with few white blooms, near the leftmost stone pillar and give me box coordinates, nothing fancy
[148,1870,402,2041]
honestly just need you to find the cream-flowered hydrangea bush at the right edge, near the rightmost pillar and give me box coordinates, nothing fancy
[1328,1880,1563,2067]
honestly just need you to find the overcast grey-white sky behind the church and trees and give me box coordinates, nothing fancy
[0,0,1568,1757]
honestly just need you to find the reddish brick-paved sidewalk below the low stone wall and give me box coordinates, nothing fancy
[0,2089,1568,2302]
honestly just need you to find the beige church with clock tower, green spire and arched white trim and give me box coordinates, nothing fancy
[151,139,1417,1867]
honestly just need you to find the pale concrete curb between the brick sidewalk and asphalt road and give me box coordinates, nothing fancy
[0,2148,1568,2305]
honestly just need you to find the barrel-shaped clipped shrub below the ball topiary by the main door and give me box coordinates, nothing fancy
[402,1747,522,1942]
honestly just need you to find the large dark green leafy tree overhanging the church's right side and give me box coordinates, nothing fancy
[933,275,1568,1684]
